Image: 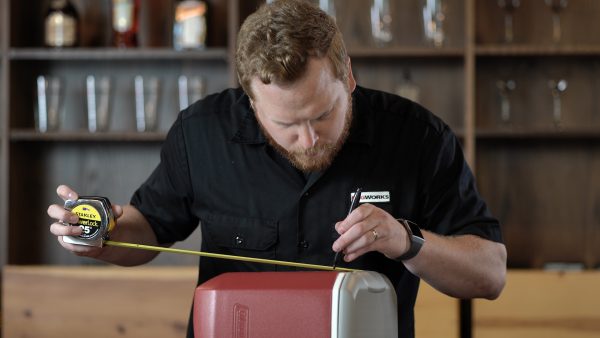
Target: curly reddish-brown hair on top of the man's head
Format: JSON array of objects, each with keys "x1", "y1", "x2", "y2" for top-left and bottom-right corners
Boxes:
[{"x1": 235, "y1": 0, "x2": 349, "y2": 98}]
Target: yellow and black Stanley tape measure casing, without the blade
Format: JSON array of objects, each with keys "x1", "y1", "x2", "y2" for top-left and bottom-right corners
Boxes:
[{"x1": 63, "y1": 196, "x2": 115, "y2": 247}]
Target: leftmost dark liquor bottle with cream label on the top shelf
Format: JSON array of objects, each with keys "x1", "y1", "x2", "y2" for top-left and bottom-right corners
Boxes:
[{"x1": 44, "y1": 0, "x2": 79, "y2": 48}]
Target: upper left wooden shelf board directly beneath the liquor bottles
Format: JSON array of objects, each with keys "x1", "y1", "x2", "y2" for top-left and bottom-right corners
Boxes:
[{"x1": 9, "y1": 48, "x2": 228, "y2": 62}]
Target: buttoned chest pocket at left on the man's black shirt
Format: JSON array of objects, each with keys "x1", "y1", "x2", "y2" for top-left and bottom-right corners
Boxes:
[{"x1": 202, "y1": 213, "x2": 278, "y2": 256}]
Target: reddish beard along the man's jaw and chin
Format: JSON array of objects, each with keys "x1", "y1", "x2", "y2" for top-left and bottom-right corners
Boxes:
[{"x1": 257, "y1": 96, "x2": 352, "y2": 173}]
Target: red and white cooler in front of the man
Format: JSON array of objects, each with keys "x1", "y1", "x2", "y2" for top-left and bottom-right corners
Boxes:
[{"x1": 194, "y1": 271, "x2": 398, "y2": 338}]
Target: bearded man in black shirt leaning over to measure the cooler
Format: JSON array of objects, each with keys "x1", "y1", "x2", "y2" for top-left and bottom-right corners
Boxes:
[{"x1": 48, "y1": 0, "x2": 506, "y2": 337}]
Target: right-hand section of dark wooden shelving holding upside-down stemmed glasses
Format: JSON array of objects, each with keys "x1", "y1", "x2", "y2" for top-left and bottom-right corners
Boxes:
[{"x1": 473, "y1": 0, "x2": 600, "y2": 269}]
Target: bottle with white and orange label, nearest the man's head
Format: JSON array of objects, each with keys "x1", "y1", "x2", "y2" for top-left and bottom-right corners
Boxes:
[{"x1": 173, "y1": 0, "x2": 206, "y2": 50}]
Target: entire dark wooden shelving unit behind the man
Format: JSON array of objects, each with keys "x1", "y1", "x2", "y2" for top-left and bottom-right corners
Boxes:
[{"x1": 0, "y1": 0, "x2": 600, "y2": 336}]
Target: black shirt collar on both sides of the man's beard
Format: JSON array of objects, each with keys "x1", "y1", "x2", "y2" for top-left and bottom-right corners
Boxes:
[{"x1": 231, "y1": 86, "x2": 375, "y2": 145}]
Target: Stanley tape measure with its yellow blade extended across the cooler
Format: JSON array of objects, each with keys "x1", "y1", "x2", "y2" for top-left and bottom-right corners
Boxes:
[{"x1": 63, "y1": 196, "x2": 359, "y2": 272}]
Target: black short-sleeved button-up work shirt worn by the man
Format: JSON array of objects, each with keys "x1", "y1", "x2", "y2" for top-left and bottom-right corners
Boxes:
[{"x1": 131, "y1": 87, "x2": 501, "y2": 337}]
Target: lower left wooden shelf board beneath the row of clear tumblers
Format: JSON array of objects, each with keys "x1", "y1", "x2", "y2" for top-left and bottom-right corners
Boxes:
[{"x1": 10, "y1": 129, "x2": 166, "y2": 142}]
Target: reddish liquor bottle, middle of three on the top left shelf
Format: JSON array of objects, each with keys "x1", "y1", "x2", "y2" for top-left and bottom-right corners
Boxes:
[{"x1": 112, "y1": 0, "x2": 140, "y2": 48}]
